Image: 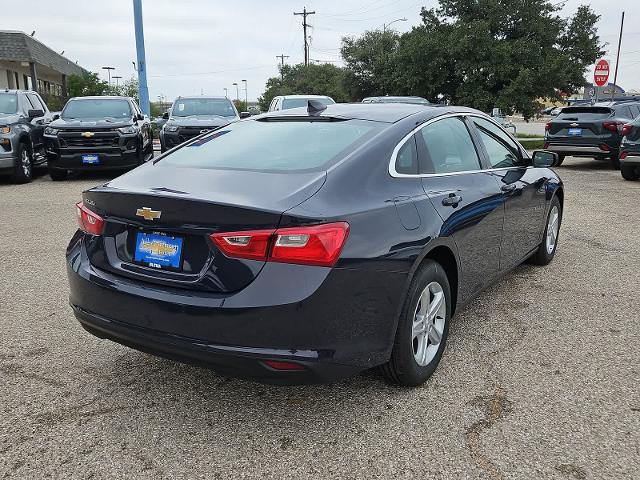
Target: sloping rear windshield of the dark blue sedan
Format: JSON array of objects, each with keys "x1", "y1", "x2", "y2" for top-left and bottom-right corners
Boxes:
[{"x1": 158, "y1": 120, "x2": 384, "y2": 172}]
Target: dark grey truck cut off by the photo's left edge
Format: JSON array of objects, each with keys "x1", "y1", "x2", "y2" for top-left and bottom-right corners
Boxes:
[{"x1": 0, "y1": 90, "x2": 51, "y2": 183}]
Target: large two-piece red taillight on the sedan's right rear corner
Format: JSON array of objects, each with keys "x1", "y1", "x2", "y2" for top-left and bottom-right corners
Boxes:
[{"x1": 211, "y1": 222, "x2": 349, "y2": 267}]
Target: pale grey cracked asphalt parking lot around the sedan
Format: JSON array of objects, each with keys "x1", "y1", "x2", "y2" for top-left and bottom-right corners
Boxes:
[{"x1": 0, "y1": 158, "x2": 640, "y2": 480}]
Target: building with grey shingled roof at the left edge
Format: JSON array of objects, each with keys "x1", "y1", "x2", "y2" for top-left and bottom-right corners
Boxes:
[{"x1": 0, "y1": 30, "x2": 86, "y2": 97}]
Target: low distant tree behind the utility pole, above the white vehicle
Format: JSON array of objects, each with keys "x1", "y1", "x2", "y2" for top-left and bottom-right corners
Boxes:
[{"x1": 258, "y1": 63, "x2": 350, "y2": 111}]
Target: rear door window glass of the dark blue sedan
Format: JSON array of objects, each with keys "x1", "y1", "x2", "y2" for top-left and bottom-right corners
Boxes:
[{"x1": 418, "y1": 117, "x2": 480, "y2": 173}]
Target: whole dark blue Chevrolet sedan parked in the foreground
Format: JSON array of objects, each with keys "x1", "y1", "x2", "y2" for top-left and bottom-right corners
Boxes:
[{"x1": 67, "y1": 101, "x2": 564, "y2": 385}]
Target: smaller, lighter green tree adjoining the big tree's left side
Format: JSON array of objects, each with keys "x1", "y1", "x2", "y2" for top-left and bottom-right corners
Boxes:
[{"x1": 341, "y1": 30, "x2": 400, "y2": 100}]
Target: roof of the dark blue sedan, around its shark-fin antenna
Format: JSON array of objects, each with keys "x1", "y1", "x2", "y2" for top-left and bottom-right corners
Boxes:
[{"x1": 256, "y1": 103, "x2": 484, "y2": 123}]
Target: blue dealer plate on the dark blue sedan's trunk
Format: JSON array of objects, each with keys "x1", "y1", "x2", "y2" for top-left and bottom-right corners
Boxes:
[{"x1": 133, "y1": 232, "x2": 183, "y2": 270}]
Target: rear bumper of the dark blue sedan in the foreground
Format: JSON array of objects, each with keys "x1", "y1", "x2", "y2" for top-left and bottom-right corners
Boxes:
[{"x1": 67, "y1": 235, "x2": 407, "y2": 383}]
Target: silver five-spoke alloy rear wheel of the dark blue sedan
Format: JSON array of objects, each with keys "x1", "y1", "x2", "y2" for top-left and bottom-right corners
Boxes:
[{"x1": 411, "y1": 282, "x2": 447, "y2": 367}]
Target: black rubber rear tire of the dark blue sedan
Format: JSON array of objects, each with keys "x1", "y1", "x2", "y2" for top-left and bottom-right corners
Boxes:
[{"x1": 381, "y1": 260, "x2": 452, "y2": 387}]
